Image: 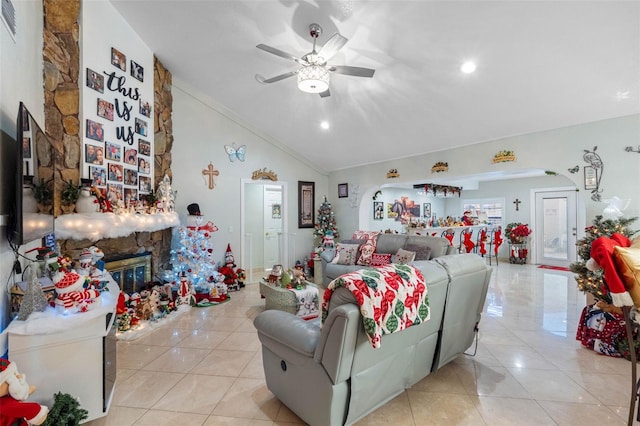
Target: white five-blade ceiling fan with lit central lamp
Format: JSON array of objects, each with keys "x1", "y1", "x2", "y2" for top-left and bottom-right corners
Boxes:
[{"x1": 256, "y1": 24, "x2": 375, "y2": 98}]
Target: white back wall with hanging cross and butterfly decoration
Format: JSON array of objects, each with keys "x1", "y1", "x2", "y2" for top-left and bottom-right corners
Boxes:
[{"x1": 171, "y1": 83, "x2": 327, "y2": 266}]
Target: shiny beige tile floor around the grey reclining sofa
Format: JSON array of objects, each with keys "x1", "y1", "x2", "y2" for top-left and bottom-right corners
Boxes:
[{"x1": 90, "y1": 263, "x2": 631, "y2": 426}]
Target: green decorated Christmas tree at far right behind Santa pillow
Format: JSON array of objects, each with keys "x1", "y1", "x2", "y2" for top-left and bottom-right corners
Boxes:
[{"x1": 571, "y1": 215, "x2": 637, "y2": 304}]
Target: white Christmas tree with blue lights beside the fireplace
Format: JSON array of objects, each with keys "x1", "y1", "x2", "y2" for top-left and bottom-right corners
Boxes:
[{"x1": 171, "y1": 222, "x2": 219, "y2": 292}]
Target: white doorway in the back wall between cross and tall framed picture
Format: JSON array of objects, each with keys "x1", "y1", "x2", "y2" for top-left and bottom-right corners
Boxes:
[{"x1": 240, "y1": 179, "x2": 288, "y2": 282}]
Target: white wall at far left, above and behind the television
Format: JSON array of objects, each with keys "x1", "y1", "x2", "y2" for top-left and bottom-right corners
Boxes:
[{"x1": 0, "y1": 0, "x2": 44, "y2": 355}]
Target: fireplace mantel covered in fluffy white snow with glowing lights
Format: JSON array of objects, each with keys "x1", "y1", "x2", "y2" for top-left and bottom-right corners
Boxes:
[{"x1": 55, "y1": 212, "x2": 180, "y2": 241}]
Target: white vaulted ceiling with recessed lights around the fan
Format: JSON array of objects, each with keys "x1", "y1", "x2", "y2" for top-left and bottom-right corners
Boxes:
[{"x1": 111, "y1": 0, "x2": 640, "y2": 171}]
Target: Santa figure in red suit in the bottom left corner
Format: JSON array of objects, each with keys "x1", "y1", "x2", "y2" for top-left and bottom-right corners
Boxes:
[{"x1": 0, "y1": 358, "x2": 49, "y2": 426}]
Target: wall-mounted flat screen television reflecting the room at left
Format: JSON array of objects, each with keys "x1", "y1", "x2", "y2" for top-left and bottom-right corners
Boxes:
[{"x1": 4, "y1": 102, "x2": 55, "y2": 248}]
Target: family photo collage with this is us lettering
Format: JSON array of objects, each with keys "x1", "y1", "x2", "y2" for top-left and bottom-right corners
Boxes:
[{"x1": 83, "y1": 47, "x2": 153, "y2": 206}]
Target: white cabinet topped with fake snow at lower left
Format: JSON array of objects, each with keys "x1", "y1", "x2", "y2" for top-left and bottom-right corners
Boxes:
[{"x1": 7, "y1": 282, "x2": 118, "y2": 421}]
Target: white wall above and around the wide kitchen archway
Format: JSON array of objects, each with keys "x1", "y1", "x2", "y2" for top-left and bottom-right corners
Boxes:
[{"x1": 329, "y1": 115, "x2": 640, "y2": 240}]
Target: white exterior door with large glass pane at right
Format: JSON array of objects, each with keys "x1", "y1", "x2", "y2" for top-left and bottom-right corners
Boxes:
[{"x1": 534, "y1": 190, "x2": 577, "y2": 268}]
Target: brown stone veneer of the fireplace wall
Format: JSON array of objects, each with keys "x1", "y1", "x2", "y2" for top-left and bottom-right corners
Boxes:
[{"x1": 42, "y1": 0, "x2": 173, "y2": 275}]
